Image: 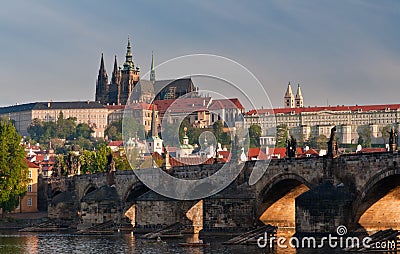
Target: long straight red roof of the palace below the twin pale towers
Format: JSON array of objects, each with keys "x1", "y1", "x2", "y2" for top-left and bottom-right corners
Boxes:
[{"x1": 246, "y1": 104, "x2": 400, "y2": 115}]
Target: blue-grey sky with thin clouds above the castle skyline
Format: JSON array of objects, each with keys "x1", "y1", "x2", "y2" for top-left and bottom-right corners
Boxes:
[{"x1": 0, "y1": 0, "x2": 400, "y2": 107}]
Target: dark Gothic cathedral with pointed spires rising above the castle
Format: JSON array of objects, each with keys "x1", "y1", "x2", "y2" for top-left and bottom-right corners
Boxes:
[{"x1": 95, "y1": 37, "x2": 197, "y2": 105}]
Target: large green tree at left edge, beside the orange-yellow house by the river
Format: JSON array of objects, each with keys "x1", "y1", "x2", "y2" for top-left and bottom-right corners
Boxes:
[{"x1": 0, "y1": 120, "x2": 29, "y2": 214}]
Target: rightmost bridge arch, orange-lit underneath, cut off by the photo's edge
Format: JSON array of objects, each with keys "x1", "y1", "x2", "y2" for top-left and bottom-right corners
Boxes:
[{"x1": 353, "y1": 167, "x2": 400, "y2": 231}]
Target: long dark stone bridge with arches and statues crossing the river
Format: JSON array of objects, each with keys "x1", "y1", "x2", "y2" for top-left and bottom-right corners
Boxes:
[{"x1": 48, "y1": 153, "x2": 400, "y2": 233}]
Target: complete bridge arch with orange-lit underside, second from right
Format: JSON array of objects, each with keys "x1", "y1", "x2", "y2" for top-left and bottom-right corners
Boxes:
[{"x1": 256, "y1": 173, "x2": 312, "y2": 227}]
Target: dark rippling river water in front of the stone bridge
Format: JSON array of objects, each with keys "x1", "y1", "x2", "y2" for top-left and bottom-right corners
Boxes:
[{"x1": 0, "y1": 231, "x2": 346, "y2": 254}]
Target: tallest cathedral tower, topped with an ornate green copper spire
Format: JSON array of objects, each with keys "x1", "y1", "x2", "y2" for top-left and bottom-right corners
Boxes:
[{"x1": 118, "y1": 36, "x2": 140, "y2": 104}]
